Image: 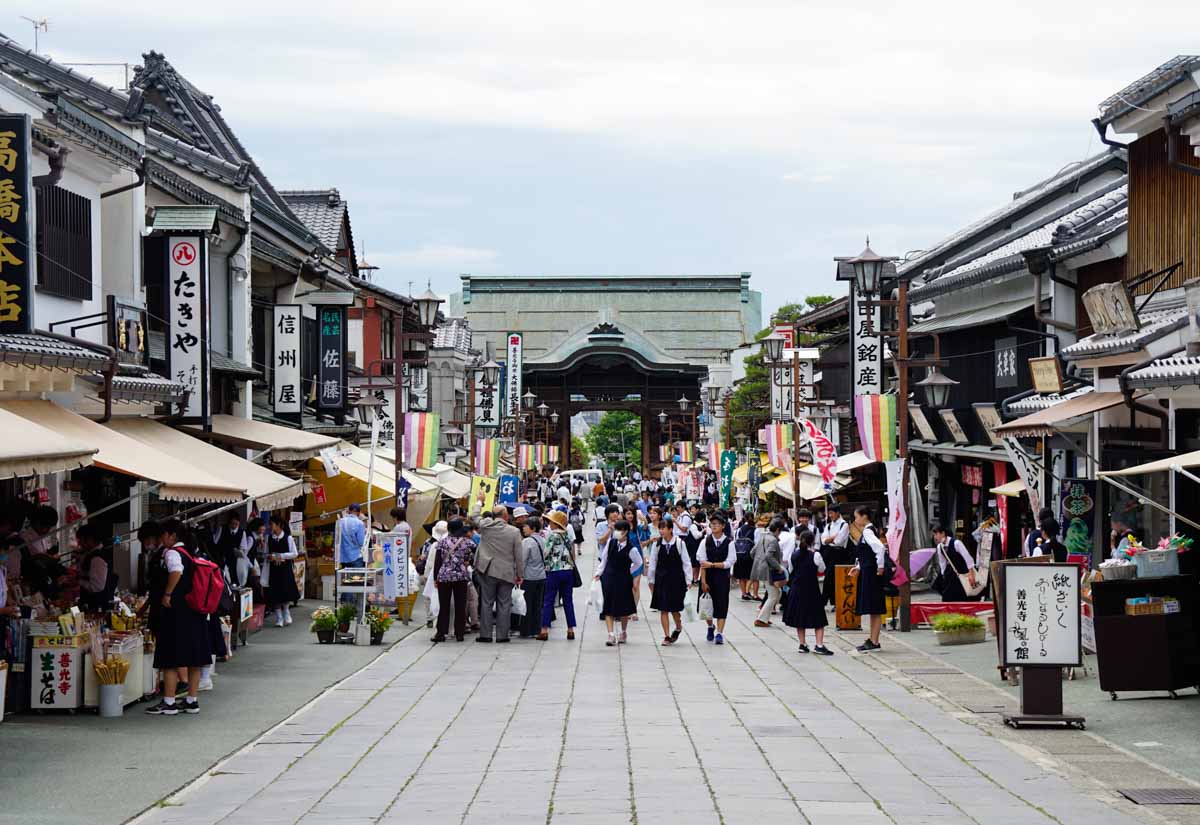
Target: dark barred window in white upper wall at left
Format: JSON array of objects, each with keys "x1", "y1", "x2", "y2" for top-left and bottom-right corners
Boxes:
[{"x1": 37, "y1": 186, "x2": 91, "y2": 301}]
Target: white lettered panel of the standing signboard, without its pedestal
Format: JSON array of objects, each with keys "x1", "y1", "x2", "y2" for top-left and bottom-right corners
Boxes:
[{"x1": 1002, "y1": 564, "x2": 1081, "y2": 668}]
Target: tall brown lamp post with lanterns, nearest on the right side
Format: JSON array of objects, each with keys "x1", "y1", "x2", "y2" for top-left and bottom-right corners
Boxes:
[{"x1": 847, "y1": 239, "x2": 958, "y2": 633}]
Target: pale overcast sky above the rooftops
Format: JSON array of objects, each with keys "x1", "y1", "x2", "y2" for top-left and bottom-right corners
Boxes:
[{"x1": 14, "y1": 0, "x2": 1200, "y2": 323}]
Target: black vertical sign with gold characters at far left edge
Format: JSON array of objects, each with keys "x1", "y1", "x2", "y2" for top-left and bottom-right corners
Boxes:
[{"x1": 0, "y1": 114, "x2": 34, "y2": 332}]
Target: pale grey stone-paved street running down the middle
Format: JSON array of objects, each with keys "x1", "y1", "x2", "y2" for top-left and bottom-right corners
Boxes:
[{"x1": 129, "y1": 534, "x2": 1144, "y2": 825}]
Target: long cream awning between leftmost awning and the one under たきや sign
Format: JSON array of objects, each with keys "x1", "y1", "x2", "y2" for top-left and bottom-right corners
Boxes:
[{"x1": 0, "y1": 401, "x2": 246, "y2": 502}]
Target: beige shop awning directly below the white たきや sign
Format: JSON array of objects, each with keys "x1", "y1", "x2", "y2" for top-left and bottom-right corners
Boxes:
[{"x1": 107, "y1": 418, "x2": 304, "y2": 510}]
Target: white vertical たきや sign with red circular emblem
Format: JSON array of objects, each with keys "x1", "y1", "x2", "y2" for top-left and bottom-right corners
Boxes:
[{"x1": 167, "y1": 235, "x2": 210, "y2": 427}]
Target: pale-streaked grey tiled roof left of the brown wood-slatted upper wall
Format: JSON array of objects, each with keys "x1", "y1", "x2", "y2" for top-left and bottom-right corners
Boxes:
[{"x1": 910, "y1": 179, "x2": 1128, "y2": 301}]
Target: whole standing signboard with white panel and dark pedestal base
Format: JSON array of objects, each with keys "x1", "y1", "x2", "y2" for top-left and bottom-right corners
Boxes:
[{"x1": 1001, "y1": 564, "x2": 1084, "y2": 727}]
